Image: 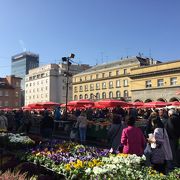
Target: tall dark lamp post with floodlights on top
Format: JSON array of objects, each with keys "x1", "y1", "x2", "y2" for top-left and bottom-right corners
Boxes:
[{"x1": 62, "y1": 54, "x2": 75, "y2": 120}]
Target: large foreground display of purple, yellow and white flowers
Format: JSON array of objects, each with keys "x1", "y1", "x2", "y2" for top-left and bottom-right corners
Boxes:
[{"x1": 25, "y1": 140, "x2": 179, "y2": 180}]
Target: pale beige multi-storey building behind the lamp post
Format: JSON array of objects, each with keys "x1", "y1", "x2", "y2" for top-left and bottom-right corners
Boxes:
[{"x1": 25, "y1": 63, "x2": 89, "y2": 105}]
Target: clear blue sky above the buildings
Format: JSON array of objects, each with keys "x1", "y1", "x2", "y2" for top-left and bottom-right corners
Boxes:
[{"x1": 0, "y1": 0, "x2": 180, "y2": 77}]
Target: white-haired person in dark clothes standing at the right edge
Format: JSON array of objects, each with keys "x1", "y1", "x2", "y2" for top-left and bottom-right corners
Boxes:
[{"x1": 166, "y1": 109, "x2": 180, "y2": 167}]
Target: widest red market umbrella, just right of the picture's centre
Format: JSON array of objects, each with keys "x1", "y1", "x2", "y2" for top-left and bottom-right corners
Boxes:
[{"x1": 95, "y1": 99, "x2": 128, "y2": 107}]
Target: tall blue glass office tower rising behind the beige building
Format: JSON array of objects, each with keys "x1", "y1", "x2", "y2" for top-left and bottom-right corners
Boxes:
[{"x1": 11, "y1": 52, "x2": 39, "y2": 105}]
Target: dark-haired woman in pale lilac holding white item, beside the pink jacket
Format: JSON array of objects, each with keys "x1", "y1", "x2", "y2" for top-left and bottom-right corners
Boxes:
[{"x1": 148, "y1": 117, "x2": 172, "y2": 174}]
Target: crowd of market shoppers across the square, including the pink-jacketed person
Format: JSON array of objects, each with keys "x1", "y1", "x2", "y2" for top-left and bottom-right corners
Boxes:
[{"x1": 0, "y1": 107, "x2": 180, "y2": 173}]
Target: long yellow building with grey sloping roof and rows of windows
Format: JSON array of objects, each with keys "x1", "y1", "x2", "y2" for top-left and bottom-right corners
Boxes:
[{"x1": 73, "y1": 57, "x2": 158, "y2": 101}]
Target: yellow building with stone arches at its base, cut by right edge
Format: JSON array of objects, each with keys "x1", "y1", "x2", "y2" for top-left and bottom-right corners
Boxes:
[{"x1": 129, "y1": 60, "x2": 180, "y2": 102}]
